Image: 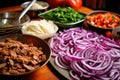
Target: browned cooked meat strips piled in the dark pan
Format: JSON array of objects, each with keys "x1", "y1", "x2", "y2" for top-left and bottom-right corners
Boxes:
[{"x1": 0, "y1": 38, "x2": 46, "y2": 74}]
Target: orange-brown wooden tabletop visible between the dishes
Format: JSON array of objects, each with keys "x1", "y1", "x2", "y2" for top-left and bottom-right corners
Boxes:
[{"x1": 0, "y1": 6, "x2": 92, "y2": 80}]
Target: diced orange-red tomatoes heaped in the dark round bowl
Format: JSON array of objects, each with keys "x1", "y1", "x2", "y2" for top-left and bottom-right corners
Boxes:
[{"x1": 87, "y1": 12, "x2": 120, "y2": 29}]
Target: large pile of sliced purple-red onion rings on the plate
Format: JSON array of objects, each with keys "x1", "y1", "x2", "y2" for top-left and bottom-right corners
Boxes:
[{"x1": 50, "y1": 28, "x2": 120, "y2": 80}]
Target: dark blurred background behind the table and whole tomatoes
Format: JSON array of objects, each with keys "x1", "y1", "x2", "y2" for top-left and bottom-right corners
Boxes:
[{"x1": 0, "y1": 0, "x2": 120, "y2": 13}]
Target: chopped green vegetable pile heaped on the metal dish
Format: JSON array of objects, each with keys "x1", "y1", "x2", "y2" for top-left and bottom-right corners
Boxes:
[{"x1": 41, "y1": 7, "x2": 85, "y2": 23}]
